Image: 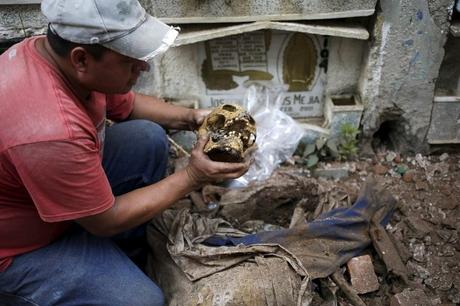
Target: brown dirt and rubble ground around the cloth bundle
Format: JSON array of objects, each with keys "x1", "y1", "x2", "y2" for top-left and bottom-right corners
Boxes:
[{"x1": 167, "y1": 146, "x2": 460, "y2": 306}]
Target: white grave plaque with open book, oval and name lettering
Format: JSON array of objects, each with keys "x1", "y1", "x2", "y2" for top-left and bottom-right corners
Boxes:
[{"x1": 199, "y1": 30, "x2": 328, "y2": 118}]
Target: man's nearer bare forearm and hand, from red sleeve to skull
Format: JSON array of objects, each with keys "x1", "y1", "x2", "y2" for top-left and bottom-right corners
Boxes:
[{"x1": 76, "y1": 138, "x2": 250, "y2": 236}]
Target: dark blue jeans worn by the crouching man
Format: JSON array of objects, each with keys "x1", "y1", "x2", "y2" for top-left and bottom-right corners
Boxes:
[{"x1": 0, "y1": 120, "x2": 168, "y2": 306}]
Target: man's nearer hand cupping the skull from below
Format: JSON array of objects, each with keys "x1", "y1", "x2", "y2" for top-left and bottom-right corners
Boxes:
[{"x1": 185, "y1": 137, "x2": 252, "y2": 188}]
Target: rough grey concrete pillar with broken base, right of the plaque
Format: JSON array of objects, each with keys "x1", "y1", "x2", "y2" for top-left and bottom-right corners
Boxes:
[{"x1": 360, "y1": 0, "x2": 454, "y2": 151}]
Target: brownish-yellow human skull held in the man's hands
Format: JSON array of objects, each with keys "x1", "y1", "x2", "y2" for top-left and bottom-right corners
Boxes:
[{"x1": 198, "y1": 104, "x2": 256, "y2": 162}]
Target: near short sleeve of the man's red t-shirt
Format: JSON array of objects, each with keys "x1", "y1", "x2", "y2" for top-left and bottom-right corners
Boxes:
[{"x1": 8, "y1": 140, "x2": 115, "y2": 222}]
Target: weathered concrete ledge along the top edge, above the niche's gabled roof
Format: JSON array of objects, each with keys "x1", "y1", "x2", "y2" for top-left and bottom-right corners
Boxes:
[{"x1": 140, "y1": 0, "x2": 377, "y2": 23}]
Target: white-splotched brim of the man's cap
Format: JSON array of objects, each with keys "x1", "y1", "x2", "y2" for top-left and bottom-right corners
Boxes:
[{"x1": 102, "y1": 14, "x2": 179, "y2": 61}]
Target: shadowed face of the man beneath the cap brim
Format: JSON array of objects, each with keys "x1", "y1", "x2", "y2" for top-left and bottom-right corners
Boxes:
[{"x1": 83, "y1": 50, "x2": 150, "y2": 94}]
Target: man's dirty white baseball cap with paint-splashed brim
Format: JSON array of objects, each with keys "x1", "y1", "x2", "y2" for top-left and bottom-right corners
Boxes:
[{"x1": 41, "y1": 0, "x2": 179, "y2": 61}]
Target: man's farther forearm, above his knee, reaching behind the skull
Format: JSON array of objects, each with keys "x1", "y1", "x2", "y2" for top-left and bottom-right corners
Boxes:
[{"x1": 129, "y1": 93, "x2": 209, "y2": 130}]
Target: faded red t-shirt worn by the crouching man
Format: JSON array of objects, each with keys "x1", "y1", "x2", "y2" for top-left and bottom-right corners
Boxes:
[{"x1": 0, "y1": 37, "x2": 134, "y2": 271}]
